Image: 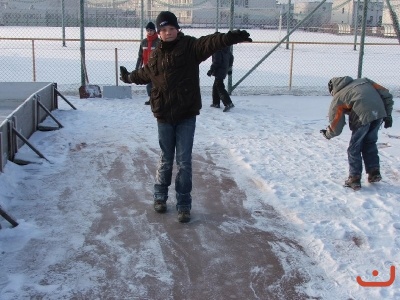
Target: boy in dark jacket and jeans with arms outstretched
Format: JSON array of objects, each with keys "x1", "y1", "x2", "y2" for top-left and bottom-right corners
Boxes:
[{"x1": 120, "y1": 11, "x2": 252, "y2": 222}]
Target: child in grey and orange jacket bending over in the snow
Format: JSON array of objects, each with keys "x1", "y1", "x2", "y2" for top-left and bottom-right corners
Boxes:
[{"x1": 321, "y1": 76, "x2": 393, "y2": 190}]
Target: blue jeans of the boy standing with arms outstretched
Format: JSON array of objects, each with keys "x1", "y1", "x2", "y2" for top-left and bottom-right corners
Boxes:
[{"x1": 154, "y1": 117, "x2": 196, "y2": 211}]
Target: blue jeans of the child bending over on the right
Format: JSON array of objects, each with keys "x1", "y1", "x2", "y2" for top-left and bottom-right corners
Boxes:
[{"x1": 347, "y1": 119, "x2": 382, "y2": 176}]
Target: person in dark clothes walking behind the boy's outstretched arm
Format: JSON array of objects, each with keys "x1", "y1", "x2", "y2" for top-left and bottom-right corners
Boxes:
[{"x1": 207, "y1": 47, "x2": 234, "y2": 112}]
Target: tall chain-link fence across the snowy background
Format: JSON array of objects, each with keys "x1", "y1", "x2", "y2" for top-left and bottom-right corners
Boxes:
[{"x1": 0, "y1": 0, "x2": 400, "y2": 97}]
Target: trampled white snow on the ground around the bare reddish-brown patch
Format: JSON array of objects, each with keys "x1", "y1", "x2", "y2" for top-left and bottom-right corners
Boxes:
[{"x1": 0, "y1": 95, "x2": 400, "y2": 299}]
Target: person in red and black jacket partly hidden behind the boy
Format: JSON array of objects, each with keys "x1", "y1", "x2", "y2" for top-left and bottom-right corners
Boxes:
[{"x1": 136, "y1": 22, "x2": 160, "y2": 105}]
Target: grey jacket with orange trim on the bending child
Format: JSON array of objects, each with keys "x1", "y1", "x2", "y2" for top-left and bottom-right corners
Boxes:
[{"x1": 326, "y1": 76, "x2": 393, "y2": 138}]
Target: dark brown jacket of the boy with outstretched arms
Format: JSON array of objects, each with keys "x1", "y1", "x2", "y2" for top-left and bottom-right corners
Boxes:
[{"x1": 130, "y1": 32, "x2": 233, "y2": 123}]
